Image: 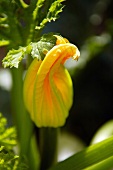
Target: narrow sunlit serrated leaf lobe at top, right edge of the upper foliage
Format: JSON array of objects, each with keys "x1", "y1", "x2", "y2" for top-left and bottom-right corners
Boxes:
[{"x1": 35, "y1": 0, "x2": 64, "y2": 30}]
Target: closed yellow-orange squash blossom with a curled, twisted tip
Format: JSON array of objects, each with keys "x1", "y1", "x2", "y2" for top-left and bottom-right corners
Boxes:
[{"x1": 24, "y1": 35, "x2": 80, "y2": 127}]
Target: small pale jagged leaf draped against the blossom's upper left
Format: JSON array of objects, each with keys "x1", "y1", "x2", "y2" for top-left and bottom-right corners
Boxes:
[{"x1": 3, "y1": 33, "x2": 56, "y2": 68}]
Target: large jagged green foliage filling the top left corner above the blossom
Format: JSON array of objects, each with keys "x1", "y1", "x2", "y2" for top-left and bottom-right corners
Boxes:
[{"x1": 0, "y1": 0, "x2": 64, "y2": 49}]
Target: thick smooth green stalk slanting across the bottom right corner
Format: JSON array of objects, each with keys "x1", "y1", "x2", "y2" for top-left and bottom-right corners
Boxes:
[{"x1": 50, "y1": 136, "x2": 113, "y2": 170}]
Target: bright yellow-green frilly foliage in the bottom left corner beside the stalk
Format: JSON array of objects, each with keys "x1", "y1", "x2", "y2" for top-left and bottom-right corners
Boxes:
[{"x1": 0, "y1": 113, "x2": 28, "y2": 170}]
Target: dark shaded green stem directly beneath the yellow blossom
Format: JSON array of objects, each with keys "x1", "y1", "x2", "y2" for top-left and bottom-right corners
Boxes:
[{"x1": 40, "y1": 128, "x2": 59, "y2": 170}]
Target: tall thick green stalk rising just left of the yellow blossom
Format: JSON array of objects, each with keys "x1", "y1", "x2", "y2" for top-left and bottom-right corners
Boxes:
[{"x1": 11, "y1": 65, "x2": 33, "y2": 155}]
